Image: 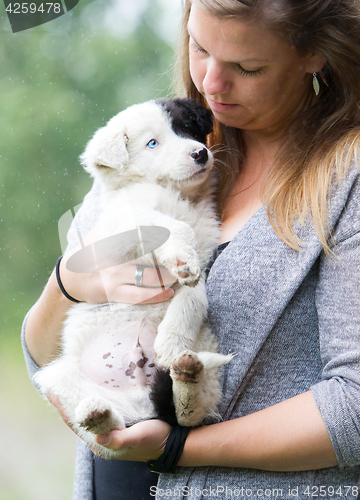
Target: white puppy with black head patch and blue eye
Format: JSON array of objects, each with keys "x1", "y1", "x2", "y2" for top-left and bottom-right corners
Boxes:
[{"x1": 35, "y1": 99, "x2": 231, "y2": 458}]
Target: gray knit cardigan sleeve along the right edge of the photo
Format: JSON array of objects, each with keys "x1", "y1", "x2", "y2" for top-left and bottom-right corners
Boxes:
[{"x1": 311, "y1": 176, "x2": 360, "y2": 467}]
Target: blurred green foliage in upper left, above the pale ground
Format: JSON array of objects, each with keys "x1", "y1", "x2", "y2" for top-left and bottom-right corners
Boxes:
[{"x1": 0, "y1": 0, "x2": 174, "y2": 344}]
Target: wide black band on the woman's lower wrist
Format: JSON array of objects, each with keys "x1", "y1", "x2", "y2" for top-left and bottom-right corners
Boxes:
[{"x1": 147, "y1": 425, "x2": 190, "y2": 473}]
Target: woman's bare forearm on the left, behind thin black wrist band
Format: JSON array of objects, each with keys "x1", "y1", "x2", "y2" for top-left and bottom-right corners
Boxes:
[{"x1": 25, "y1": 272, "x2": 73, "y2": 367}]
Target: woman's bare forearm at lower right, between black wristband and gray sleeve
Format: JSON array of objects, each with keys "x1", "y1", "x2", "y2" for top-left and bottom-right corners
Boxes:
[{"x1": 179, "y1": 391, "x2": 338, "y2": 471}]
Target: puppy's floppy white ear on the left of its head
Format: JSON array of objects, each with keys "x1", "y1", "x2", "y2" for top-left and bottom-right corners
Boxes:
[{"x1": 80, "y1": 126, "x2": 129, "y2": 176}]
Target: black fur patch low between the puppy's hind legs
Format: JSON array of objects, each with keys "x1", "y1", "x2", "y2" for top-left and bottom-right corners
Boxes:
[{"x1": 149, "y1": 369, "x2": 177, "y2": 426}]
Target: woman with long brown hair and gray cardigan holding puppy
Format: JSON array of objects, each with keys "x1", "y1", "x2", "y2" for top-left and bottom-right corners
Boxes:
[{"x1": 21, "y1": 0, "x2": 360, "y2": 499}]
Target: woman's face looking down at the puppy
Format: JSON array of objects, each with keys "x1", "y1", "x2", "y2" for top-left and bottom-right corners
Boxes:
[{"x1": 188, "y1": 5, "x2": 324, "y2": 135}]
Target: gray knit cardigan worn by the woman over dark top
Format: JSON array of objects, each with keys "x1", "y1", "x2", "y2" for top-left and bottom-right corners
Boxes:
[{"x1": 23, "y1": 165, "x2": 360, "y2": 500}]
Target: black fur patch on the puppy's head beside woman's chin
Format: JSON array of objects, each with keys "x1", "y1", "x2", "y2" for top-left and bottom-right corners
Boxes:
[{"x1": 155, "y1": 99, "x2": 213, "y2": 144}]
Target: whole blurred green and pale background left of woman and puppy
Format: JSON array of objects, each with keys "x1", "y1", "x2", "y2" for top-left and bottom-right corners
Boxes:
[{"x1": 0, "y1": 0, "x2": 181, "y2": 500}]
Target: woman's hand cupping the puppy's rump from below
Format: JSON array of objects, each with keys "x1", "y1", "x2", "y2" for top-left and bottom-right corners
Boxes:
[{"x1": 48, "y1": 394, "x2": 171, "y2": 462}]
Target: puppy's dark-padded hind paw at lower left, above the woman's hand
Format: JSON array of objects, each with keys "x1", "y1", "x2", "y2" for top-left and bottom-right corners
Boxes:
[{"x1": 75, "y1": 398, "x2": 125, "y2": 434}]
